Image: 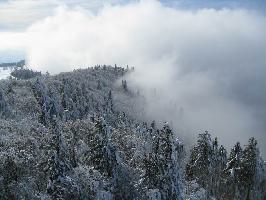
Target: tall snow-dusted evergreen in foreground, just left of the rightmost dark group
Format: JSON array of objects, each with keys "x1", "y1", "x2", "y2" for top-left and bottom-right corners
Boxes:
[{"x1": 144, "y1": 124, "x2": 182, "y2": 199}]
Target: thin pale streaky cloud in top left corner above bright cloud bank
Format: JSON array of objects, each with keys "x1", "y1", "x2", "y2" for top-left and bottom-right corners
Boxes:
[{"x1": 0, "y1": 0, "x2": 128, "y2": 30}]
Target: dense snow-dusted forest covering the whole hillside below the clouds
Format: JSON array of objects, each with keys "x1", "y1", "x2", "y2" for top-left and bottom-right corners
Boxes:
[{"x1": 0, "y1": 65, "x2": 266, "y2": 200}]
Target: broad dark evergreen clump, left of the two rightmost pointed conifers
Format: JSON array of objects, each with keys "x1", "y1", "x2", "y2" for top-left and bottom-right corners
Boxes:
[{"x1": 186, "y1": 131, "x2": 227, "y2": 199}]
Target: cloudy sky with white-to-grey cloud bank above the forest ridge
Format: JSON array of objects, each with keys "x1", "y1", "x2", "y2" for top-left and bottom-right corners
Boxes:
[{"x1": 0, "y1": 0, "x2": 266, "y2": 157}]
